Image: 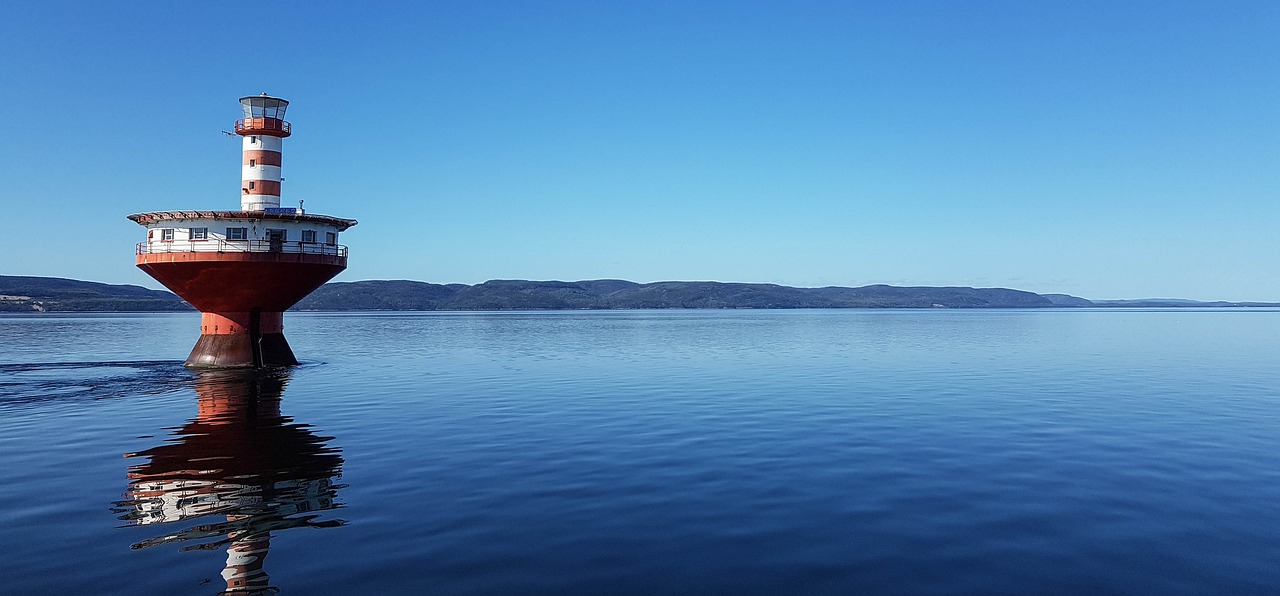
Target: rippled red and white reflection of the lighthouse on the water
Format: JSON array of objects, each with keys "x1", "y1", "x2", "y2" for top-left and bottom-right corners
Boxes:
[{"x1": 115, "y1": 368, "x2": 344, "y2": 595}]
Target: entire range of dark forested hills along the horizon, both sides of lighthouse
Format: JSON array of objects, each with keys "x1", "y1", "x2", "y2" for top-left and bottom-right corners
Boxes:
[{"x1": 0, "y1": 275, "x2": 1280, "y2": 312}]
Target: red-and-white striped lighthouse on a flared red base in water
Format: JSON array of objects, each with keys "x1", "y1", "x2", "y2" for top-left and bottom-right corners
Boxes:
[{"x1": 129, "y1": 93, "x2": 356, "y2": 367}]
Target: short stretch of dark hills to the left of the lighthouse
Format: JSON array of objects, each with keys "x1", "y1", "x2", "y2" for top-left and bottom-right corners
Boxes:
[{"x1": 0, "y1": 275, "x2": 191, "y2": 312}]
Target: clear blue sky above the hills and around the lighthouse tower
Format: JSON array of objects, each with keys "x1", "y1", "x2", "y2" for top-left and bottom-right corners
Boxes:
[{"x1": 0, "y1": 0, "x2": 1280, "y2": 301}]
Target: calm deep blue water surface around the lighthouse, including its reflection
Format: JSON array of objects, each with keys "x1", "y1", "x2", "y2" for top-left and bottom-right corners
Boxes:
[{"x1": 0, "y1": 310, "x2": 1280, "y2": 595}]
